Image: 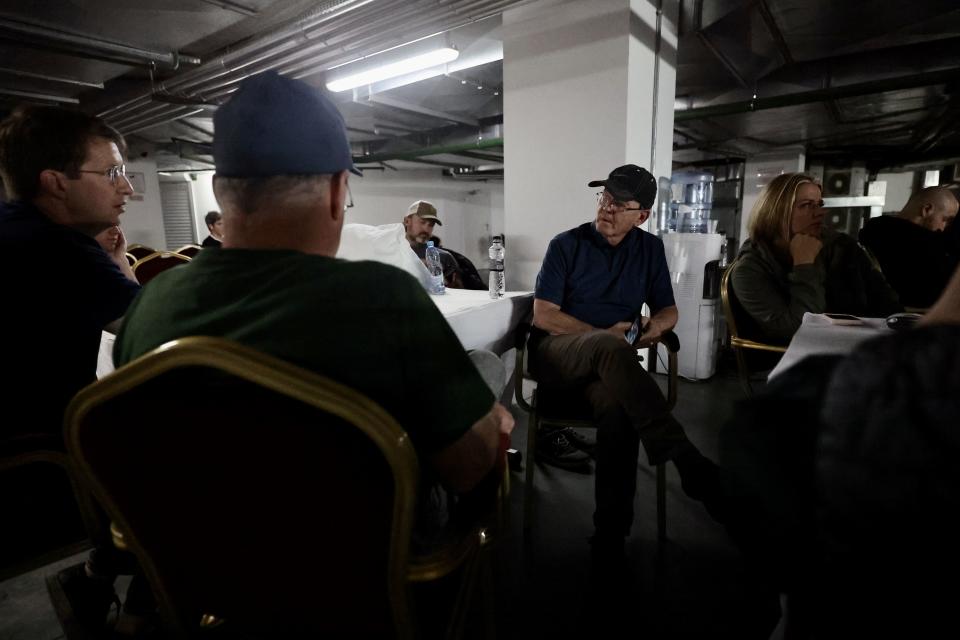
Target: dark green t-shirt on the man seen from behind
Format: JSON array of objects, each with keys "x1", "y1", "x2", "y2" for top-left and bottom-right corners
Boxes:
[{"x1": 113, "y1": 249, "x2": 494, "y2": 453}]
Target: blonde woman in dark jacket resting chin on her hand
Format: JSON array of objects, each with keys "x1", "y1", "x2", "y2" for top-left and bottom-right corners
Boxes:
[{"x1": 731, "y1": 173, "x2": 902, "y2": 344}]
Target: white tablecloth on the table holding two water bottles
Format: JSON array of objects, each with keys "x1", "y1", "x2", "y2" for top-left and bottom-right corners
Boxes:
[{"x1": 97, "y1": 289, "x2": 533, "y2": 378}]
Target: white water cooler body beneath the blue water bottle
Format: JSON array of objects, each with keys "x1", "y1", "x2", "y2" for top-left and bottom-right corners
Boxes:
[{"x1": 659, "y1": 233, "x2": 724, "y2": 380}]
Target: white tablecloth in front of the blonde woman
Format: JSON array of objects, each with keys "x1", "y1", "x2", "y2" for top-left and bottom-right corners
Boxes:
[{"x1": 767, "y1": 313, "x2": 891, "y2": 380}]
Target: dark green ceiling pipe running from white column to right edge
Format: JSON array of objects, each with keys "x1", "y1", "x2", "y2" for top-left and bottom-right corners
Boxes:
[{"x1": 673, "y1": 68, "x2": 960, "y2": 122}]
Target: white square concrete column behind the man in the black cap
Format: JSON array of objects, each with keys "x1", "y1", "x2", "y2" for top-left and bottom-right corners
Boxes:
[{"x1": 503, "y1": 0, "x2": 679, "y2": 289}]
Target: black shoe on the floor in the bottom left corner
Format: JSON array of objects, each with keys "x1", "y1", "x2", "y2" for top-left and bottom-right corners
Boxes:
[{"x1": 47, "y1": 562, "x2": 120, "y2": 639}]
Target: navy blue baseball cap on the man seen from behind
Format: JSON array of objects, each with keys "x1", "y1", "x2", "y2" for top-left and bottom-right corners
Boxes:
[{"x1": 213, "y1": 71, "x2": 361, "y2": 178}]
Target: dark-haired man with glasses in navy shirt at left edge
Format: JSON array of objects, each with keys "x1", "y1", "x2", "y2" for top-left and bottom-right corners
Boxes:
[{"x1": 0, "y1": 107, "x2": 140, "y2": 437}]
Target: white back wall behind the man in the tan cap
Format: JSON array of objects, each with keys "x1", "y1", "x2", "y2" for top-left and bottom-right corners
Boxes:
[{"x1": 184, "y1": 169, "x2": 510, "y2": 269}]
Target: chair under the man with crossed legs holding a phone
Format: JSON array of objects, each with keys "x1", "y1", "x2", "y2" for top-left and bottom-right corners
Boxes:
[{"x1": 514, "y1": 324, "x2": 680, "y2": 547}]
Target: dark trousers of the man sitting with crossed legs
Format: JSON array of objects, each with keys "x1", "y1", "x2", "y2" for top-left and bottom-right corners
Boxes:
[{"x1": 530, "y1": 331, "x2": 693, "y2": 535}]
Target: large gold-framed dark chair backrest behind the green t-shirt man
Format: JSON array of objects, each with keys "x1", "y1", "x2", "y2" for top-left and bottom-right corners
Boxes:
[{"x1": 66, "y1": 338, "x2": 417, "y2": 637}]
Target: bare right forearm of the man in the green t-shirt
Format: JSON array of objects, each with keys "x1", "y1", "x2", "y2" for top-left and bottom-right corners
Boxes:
[{"x1": 431, "y1": 402, "x2": 513, "y2": 493}]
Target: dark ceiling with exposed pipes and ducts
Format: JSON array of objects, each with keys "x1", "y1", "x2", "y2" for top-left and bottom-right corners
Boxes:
[{"x1": 0, "y1": 0, "x2": 960, "y2": 178}]
